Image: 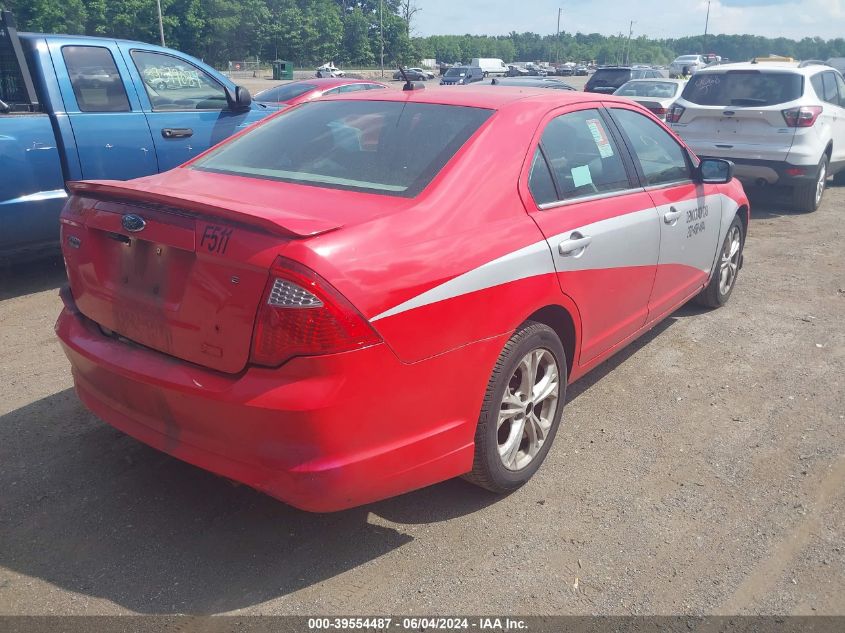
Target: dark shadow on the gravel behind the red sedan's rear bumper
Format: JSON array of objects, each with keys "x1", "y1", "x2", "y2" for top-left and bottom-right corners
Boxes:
[{"x1": 0, "y1": 389, "x2": 498, "y2": 614}]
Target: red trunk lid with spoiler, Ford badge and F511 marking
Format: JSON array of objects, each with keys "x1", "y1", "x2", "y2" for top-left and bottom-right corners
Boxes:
[{"x1": 62, "y1": 170, "x2": 352, "y2": 373}]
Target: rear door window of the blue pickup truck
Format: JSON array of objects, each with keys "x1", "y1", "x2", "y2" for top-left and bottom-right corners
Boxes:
[{"x1": 62, "y1": 46, "x2": 129, "y2": 112}]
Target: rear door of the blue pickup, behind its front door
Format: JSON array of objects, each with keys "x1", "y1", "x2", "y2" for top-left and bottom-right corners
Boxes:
[{"x1": 48, "y1": 39, "x2": 158, "y2": 180}]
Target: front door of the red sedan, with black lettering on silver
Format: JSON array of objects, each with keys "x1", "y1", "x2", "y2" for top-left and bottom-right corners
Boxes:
[{"x1": 608, "y1": 104, "x2": 722, "y2": 320}]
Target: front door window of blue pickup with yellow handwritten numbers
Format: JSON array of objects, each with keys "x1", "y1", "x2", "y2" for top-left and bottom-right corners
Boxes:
[{"x1": 131, "y1": 51, "x2": 227, "y2": 110}]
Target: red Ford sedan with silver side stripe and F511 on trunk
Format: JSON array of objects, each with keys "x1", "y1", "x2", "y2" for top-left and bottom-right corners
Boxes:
[{"x1": 56, "y1": 87, "x2": 749, "y2": 511}]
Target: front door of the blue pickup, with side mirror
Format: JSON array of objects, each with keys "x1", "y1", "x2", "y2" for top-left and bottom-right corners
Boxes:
[{"x1": 121, "y1": 44, "x2": 267, "y2": 171}]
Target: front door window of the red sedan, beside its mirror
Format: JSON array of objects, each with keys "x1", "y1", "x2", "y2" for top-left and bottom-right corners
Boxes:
[{"x1": 611, "y1": 108, "x2": 691, "y2": 185}]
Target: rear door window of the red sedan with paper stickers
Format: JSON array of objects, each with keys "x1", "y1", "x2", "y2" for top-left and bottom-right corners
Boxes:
[{"x1": 540, "y1": 110, "x2": 629, "y2": 198}]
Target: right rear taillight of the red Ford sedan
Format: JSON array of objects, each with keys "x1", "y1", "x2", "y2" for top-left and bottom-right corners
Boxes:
[{"x1": 250, "y1": 257, "x2": 381, "y2": 367}]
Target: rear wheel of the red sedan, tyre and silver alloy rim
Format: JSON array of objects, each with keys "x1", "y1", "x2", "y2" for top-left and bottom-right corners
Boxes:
[{"x1": 465, "y1": 321, "x2": 567, "y2": 494}]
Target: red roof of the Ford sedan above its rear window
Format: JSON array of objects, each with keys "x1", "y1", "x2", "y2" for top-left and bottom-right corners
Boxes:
[{"x1": 316, "y1": 84, "x2": 630, "y2": 110}]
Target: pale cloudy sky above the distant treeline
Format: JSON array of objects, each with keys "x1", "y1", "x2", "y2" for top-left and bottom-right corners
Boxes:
[{"x1": 412, "y1": 0, "x2": 845, "y2": 40}]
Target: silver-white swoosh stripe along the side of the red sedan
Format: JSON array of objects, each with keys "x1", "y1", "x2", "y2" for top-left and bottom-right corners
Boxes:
[{"x1": 370, "y1": 194, "x2": 737, "y2": 321}]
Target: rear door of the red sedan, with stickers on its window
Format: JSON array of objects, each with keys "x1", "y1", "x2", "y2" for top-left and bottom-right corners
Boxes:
[{"x1": 523, "y1": 104, "x2": 660, "y2": 364}]
